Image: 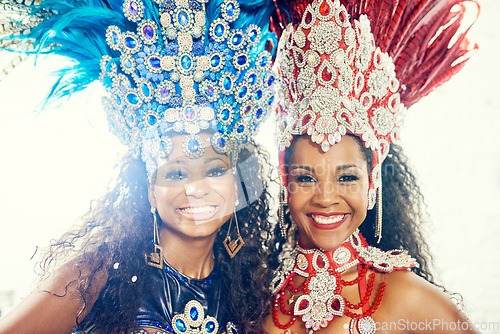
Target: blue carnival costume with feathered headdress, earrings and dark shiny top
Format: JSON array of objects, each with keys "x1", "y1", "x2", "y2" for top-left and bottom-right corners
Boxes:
[{"x1": 0, "y1": 0, "x2": 275, "y2": 333}]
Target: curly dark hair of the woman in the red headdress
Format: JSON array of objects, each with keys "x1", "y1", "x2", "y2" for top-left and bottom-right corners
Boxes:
[{"x1": 271, "y1": 134, "x2": 439, "y2": 286}]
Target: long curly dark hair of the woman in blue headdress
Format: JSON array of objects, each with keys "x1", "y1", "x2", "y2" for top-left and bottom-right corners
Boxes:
[{"x1": 39, "y1": 146, "x2": 272, "y2": 333}]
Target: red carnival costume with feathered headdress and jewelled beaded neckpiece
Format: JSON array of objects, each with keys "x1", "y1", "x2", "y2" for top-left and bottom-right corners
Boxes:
[{"x1": 272, "y1": 0, "x2": 477, "y2": 334}]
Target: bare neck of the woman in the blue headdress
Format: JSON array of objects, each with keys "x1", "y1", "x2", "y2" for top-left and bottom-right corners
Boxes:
[{"x1": 160, "y1": 228, "x2": 217, "y2": 279}]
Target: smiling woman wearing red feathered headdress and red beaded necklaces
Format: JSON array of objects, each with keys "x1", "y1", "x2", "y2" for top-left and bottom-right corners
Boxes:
[{"x1": 265, "y1": 0, "x2": 477, "y2": 334}]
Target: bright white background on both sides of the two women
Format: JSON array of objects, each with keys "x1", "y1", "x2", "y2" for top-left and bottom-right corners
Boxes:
[{"x1": 0, "y1": 0, "x2": 500, "y2": 333}]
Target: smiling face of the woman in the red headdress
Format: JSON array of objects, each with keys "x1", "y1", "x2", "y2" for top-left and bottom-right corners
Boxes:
[{"x1": 288, "y1": 136, "x2": 369, "y2": 250}]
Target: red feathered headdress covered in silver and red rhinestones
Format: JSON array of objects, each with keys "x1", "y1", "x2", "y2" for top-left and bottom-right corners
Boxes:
[{"x1": 276, "y1": 0, "x2": 476, "y2": 208}]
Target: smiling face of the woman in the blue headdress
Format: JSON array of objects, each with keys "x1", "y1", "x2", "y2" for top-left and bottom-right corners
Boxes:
[{"x1": 149, "y1": 134, "x2": 236, "y2": 238}]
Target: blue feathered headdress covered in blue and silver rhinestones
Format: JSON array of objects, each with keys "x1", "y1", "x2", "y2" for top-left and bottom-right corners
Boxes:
[{"x1": 0, "y1": 0, "x2": 275, "y2": 177}]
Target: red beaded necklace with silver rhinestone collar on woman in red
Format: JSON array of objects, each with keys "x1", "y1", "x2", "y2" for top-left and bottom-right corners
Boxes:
[{"x1": 272, "y1": 230, "x2": 415, "y2": 334}]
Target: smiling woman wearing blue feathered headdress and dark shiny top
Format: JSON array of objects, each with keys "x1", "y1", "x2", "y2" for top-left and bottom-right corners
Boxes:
[{"x1": 0, "y1": 0, "x2": 274, "y2": 334}]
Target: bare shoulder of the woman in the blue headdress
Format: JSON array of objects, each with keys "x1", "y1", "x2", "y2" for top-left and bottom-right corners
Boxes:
[{"x1": 0, "y1": 258, "x2": 107, "y2": 334}]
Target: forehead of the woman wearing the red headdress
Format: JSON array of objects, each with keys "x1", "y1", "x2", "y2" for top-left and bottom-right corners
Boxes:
[{"x1": 290, "y1": 136, "x2": 366, "y2": 168}]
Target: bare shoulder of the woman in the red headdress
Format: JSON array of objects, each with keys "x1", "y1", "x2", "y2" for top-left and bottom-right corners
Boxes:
[{"x1": 380, "y1": 271, "x2": 475, "y2": 333}]
